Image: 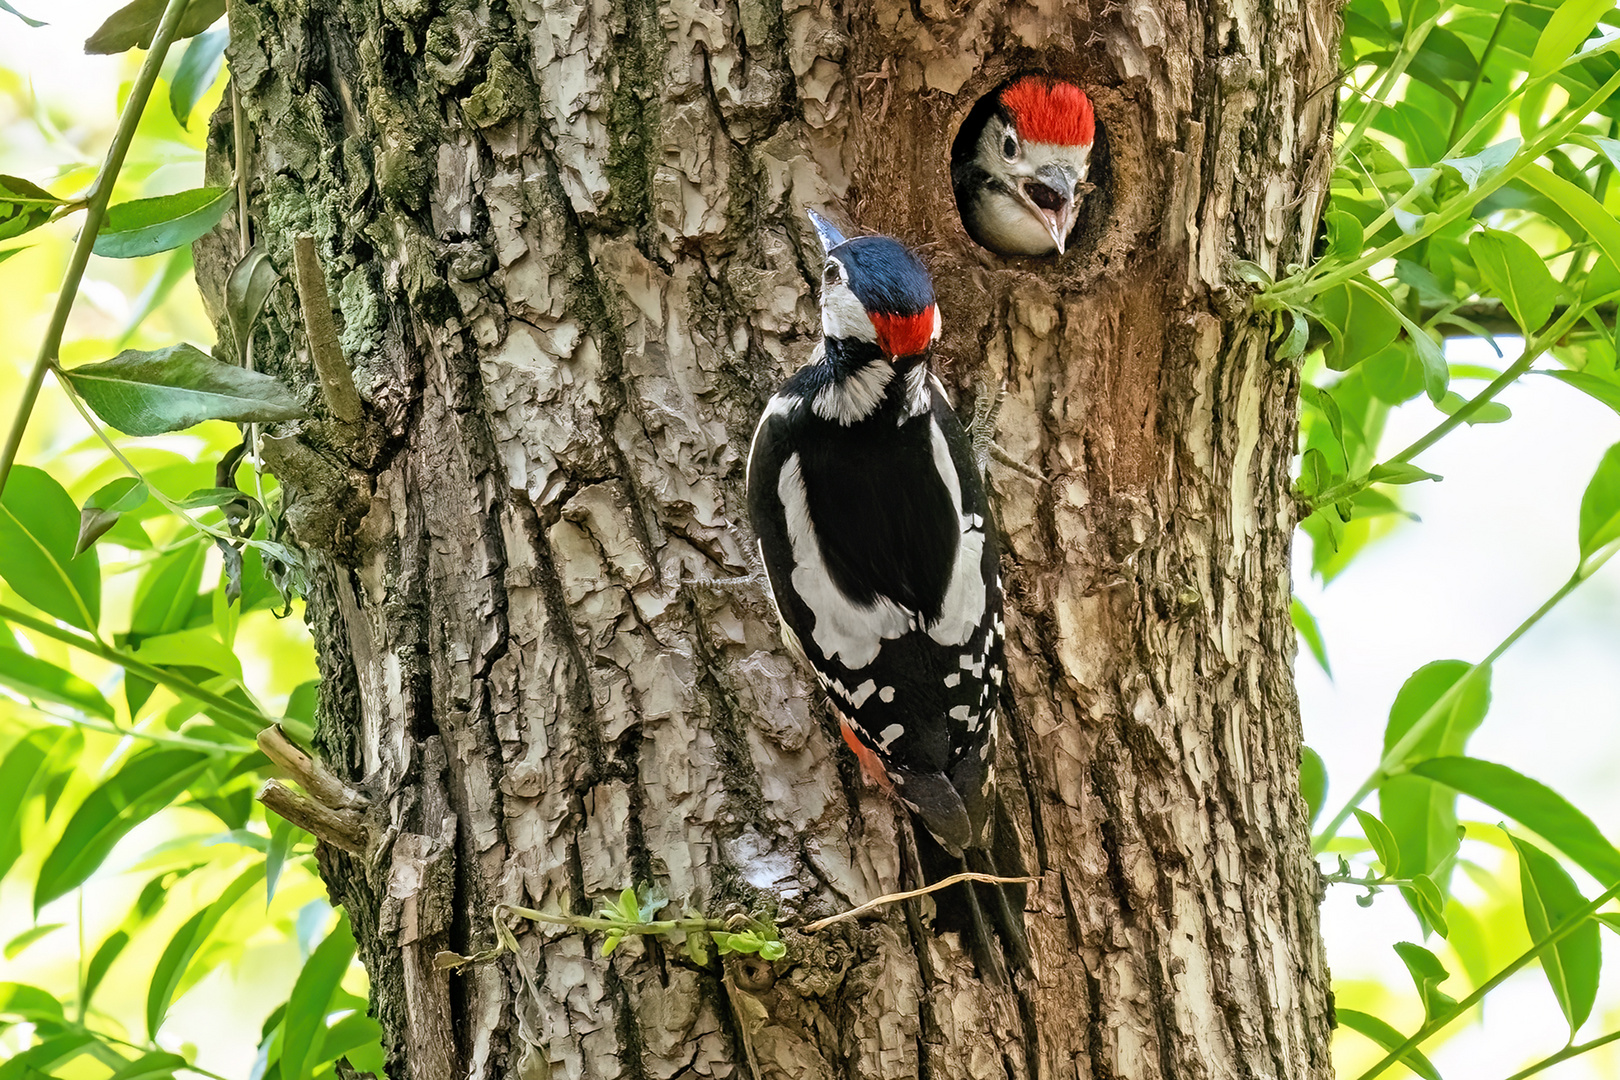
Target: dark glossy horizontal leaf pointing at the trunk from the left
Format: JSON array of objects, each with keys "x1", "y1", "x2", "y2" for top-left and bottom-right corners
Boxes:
[{"x1": 63, "y1": 345, "x2": 305, "y2": 436}]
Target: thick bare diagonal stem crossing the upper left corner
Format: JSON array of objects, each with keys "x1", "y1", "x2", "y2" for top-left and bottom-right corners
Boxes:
[{"x1": 0, "y1": 0, "x2": 191, "y2": 494}]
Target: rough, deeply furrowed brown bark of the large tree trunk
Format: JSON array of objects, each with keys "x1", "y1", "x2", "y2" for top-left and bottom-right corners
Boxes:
[{"x1": 199, "y1": 0, "x2": 1338, "y2": 1080}]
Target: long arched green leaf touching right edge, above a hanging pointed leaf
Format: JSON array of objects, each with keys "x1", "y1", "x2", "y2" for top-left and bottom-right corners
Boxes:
[{"x1": 1411, "y1": 756, "x2": 1620, "y2": 884}]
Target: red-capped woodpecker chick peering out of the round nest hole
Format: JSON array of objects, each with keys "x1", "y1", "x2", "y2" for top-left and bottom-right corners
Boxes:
[{"x1": 951, "y1": 74, "x2": 1097, "y2": 254}]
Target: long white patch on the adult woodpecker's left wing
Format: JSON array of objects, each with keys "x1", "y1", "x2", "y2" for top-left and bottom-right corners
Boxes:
[{"x1": 776, "y1": 453, "x2": 913, "y2": 667}]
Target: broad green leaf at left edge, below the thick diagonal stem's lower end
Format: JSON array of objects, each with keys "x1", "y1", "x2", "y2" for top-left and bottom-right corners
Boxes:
[{"x1": 0, "y1": 465, "x2": 100, "y2": 630}]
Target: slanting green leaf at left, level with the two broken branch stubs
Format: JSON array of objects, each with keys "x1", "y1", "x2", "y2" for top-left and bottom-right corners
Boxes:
[{"x1": 34, "y1": 746, "x2": 212, "y2": 912}]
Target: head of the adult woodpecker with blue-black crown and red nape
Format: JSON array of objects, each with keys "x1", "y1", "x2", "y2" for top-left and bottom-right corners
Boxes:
[{"x1": 810, "y1": 210, "x2": 940, "y2": 364}]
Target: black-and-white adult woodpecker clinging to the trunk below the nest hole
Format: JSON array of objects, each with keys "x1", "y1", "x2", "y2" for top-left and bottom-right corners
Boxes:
[{"x1": 748, "y1": 212, "x2": 1004, "y2": 858}]
